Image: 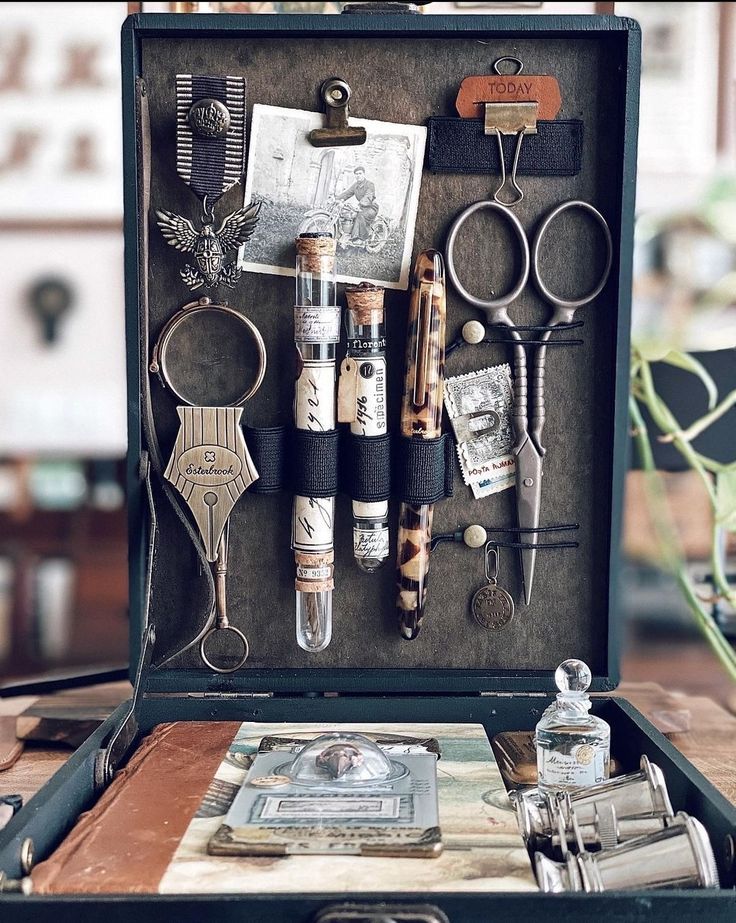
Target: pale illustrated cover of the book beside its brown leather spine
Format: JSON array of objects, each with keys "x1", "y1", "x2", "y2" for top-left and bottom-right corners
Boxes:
[{"x1": 159, "y1": 722, "x2": 537, "y2": 894}]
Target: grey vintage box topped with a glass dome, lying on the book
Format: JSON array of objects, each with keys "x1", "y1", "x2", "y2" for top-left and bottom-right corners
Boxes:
[{"x1": 213, "y1": 725, "x2": 442, "y2": 858}]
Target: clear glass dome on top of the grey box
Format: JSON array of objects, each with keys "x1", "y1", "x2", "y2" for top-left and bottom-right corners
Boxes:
[{"x1": 275, "y1": 732, "x2": 408, "y2": 788}]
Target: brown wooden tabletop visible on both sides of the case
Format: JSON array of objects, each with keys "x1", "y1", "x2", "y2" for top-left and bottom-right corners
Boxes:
[{"x1": 0, "y1": 683, "x2": 736, "y2": 804}]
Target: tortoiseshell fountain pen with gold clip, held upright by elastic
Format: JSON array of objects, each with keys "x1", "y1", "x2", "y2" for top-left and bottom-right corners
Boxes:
[{"x1": 396, "y1": 250, "x2": 445, "y2": 640}]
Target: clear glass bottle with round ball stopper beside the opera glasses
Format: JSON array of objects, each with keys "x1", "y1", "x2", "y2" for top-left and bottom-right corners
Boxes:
[{"x1": 535, "y1": 660, "x2": 611, "y2": 792}]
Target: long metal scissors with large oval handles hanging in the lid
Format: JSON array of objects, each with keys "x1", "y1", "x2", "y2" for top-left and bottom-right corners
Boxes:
[{"x1": 447, "y1": 199, "x2": 613, "y2": 605}]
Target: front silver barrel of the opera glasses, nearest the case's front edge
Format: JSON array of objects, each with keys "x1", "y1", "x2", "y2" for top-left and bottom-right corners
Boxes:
[{"x1": 534, "y1": 811, "x2": 719, "y2": 893}]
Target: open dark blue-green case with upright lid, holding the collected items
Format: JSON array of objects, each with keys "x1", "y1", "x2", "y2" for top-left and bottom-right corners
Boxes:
[{"x1": 0, "y1": 13, "x2": 736, "y2": 923}]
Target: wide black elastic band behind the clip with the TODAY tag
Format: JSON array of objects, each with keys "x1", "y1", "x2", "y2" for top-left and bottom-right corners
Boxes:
[{"x1": 427, "y1": 116, "x2": 583, "y2": 176}]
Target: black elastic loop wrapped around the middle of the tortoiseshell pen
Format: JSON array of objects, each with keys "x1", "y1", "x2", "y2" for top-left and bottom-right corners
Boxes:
[{"x1": 395, "y1": 433, "x2": 454, "y2": 506}]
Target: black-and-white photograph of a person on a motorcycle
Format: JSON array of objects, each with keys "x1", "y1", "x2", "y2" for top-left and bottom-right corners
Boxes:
[{"x1": 239, "y1": 105, "x2": 426, "y2": 289}]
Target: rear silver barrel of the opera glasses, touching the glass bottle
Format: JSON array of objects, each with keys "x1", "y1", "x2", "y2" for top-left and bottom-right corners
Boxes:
[{"x1": 514, "y1": 756, "x2": 674, "y2": 854}]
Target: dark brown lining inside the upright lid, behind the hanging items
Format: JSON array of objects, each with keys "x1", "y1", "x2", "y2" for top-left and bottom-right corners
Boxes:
[{"x1": 137, "y1": 17, "x2": 631, "y2": 692}]
